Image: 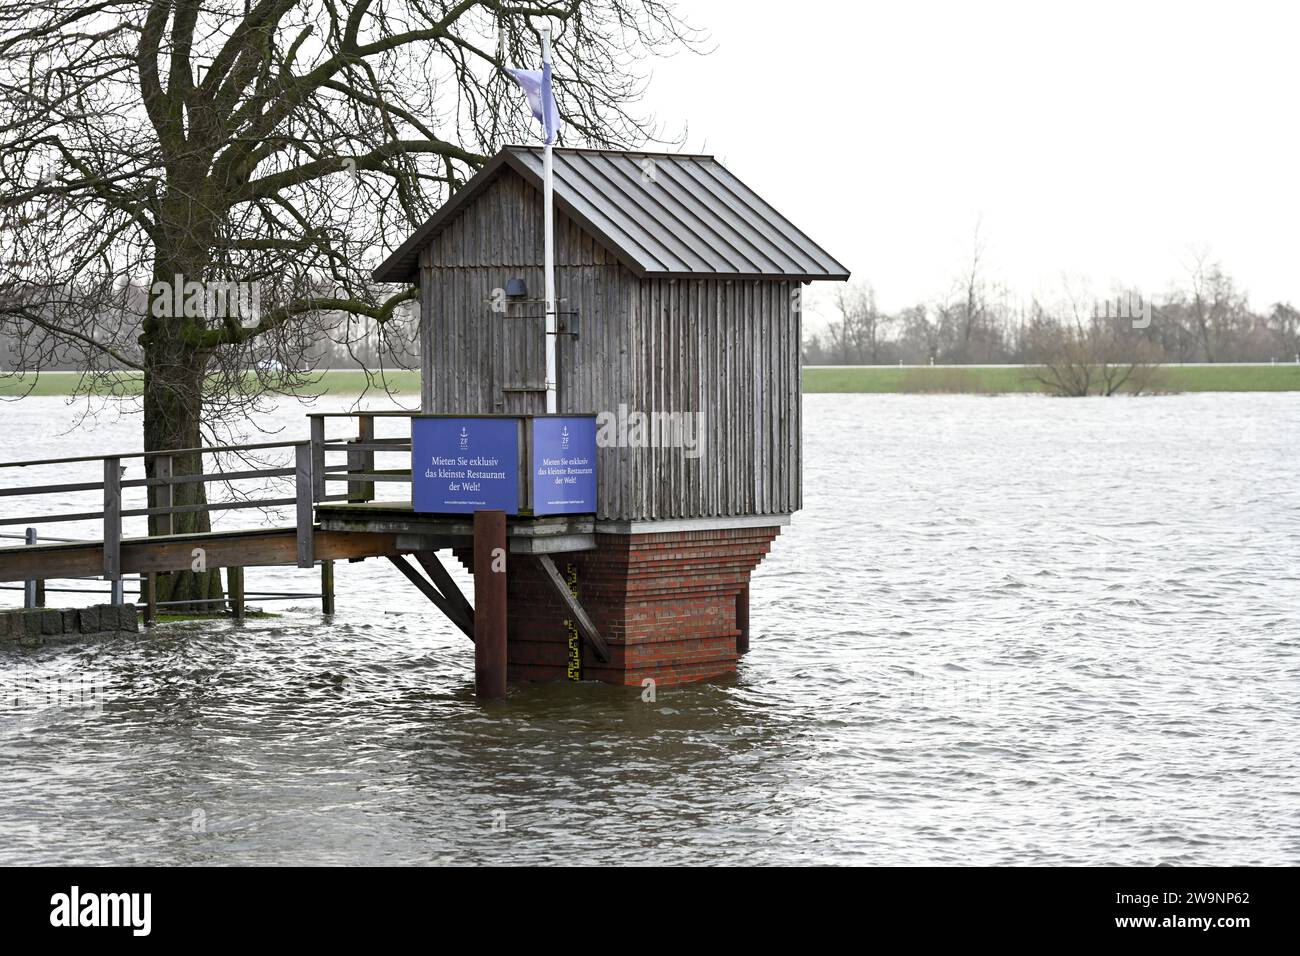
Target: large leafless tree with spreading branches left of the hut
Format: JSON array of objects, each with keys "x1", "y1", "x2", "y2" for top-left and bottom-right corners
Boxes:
[{"x1": 0, "y1": 0, "x2": 698, "y2": 598}]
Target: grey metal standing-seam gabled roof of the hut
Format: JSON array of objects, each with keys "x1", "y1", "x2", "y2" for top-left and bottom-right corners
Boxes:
[{"x1": 374, "y1": 146, "x2": 849, "y2": 282}]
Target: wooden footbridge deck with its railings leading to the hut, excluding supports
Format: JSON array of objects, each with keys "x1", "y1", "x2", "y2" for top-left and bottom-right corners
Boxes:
[{"x1": 0, "y1": 414, "x2": 595, "y2": 581}]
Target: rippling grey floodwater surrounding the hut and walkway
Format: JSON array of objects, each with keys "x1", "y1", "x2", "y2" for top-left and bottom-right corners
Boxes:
[{"x1": 0, "y1": 394, "x2": 1300, "y2": 865}]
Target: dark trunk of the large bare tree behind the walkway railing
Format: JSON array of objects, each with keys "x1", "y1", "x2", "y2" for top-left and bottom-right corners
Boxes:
[{"x1": 143, "y1": 265, "x2": 225, "y2": 614}]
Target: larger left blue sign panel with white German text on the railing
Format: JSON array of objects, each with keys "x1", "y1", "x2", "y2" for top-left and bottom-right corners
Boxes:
[{"x1": 411, "y1": 418, "x2": 519, "y2": 515}]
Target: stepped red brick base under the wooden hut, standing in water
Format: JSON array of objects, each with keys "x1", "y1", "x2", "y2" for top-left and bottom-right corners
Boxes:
[{"x1": 455, "y1": 527, "x2": 780, "y2": 685}]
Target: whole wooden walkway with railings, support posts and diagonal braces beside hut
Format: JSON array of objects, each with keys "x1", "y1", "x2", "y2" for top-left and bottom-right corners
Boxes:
[{"x1": 0, "y1": 412, "x2": 607, "y2": 659}]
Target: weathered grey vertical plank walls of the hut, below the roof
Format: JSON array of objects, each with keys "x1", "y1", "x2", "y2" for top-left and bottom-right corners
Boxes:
[{"x1": 420, "y1": 172, "x2": 801, "y2": 519}]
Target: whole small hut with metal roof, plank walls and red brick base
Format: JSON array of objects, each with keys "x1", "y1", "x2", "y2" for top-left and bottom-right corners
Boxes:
[{"x1": 374, "y1": 147, "x2": 848, "y2": 684}]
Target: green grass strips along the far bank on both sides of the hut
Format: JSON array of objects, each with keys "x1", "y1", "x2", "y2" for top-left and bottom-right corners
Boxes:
[{"x1": 0, "y1": 365, "x2": 1300, "y2": 398}]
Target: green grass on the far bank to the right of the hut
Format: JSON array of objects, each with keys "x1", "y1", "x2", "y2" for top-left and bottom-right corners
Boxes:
[{"x1": 803, "y1": 365, "x2": 1300, "y2": 395}]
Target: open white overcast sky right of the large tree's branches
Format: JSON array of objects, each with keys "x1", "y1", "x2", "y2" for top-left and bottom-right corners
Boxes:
[{"x1": 634, "y1": 0, "x2": 1300, "y2": 329}]
